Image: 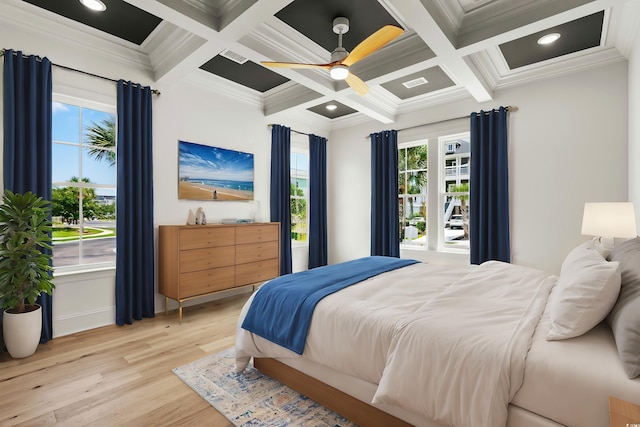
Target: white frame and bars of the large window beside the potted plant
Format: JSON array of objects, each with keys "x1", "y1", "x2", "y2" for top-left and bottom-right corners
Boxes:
[{"x1": 51, "y1": 92, "x2": 118, "y2": 276}]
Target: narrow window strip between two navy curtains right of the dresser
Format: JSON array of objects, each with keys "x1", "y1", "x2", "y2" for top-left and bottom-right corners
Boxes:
[{"x1": 290, "y1": 146, "x2": 309, "y2": 244}]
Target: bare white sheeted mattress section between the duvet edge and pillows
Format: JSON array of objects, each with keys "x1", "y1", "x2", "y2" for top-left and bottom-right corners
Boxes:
[{"x1": 511, "y1": 304, "x2": 640, "y2": 427}]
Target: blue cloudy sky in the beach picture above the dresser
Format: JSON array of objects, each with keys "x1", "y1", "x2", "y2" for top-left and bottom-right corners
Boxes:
[{"x1": 178, "y1": 141, "x2": 253, "y2": 182}]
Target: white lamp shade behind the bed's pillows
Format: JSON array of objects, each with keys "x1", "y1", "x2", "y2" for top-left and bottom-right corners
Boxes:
[{"x1": 582, "y1": 202, "x2": 637, "y2": 238}]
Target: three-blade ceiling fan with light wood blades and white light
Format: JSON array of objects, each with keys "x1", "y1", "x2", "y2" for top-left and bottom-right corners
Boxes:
[{"x1": 262, "y1": 17, "x2": 404, "y2": 96}]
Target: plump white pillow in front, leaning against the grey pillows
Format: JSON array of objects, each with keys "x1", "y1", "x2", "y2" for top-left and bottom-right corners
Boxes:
[{"x1": 547, "y1": 241, "x2": 620, "y2": 341}]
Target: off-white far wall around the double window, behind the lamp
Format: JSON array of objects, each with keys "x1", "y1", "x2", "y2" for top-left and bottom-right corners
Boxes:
[{"x1": 327, "y1": 62, "x2": 628, "y2": 273}]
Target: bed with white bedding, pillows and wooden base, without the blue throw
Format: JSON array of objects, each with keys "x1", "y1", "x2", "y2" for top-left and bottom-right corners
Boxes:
[{"x1": 236, "y1": 238, "x2": 640, "y2": 427}]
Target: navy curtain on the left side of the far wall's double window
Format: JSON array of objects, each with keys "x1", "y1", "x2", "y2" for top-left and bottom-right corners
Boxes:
[{"x1": 371, "y1": 130, "x2": 400, "y2": 257}]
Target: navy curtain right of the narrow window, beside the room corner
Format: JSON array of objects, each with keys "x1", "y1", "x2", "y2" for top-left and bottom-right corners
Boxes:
[{"x1": 308, "y1": 135, "x2": 328, "y2": 268}]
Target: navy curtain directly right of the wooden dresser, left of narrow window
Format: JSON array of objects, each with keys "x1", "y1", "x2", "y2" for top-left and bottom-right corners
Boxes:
[{"x1": 270, "y1": 125, "x2": 292, "y2": 275}]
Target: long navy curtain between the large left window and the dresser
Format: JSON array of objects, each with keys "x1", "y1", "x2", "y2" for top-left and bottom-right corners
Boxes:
[{"x1": 116, "y1": 80, "x2": 155, "y2": 325}]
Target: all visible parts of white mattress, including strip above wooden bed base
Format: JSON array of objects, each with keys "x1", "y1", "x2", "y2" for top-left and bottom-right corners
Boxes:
[{"x1": 272, "y1": 313, "x2": 640, "y2": 427}]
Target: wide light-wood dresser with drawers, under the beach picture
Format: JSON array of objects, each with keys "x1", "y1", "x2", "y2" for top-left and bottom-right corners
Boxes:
[{"x1": 158, "y1": 222, "x2": 280, "y2": 321}]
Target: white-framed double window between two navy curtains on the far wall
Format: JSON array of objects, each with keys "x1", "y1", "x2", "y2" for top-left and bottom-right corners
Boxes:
[{"x1": 398, "y1": 132, "x2": 471, "y2": 253}]
